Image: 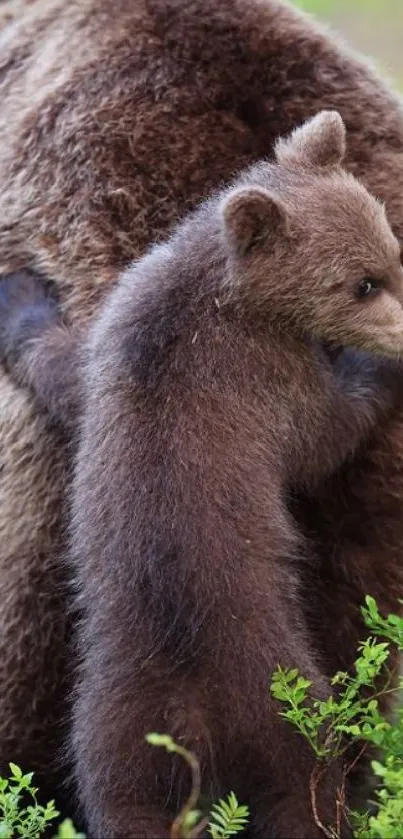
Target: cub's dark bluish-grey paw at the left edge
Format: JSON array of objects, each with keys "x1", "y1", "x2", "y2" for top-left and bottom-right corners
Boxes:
[{"x1": 0, "y1": 269, "x2": 59, "y2": 366}]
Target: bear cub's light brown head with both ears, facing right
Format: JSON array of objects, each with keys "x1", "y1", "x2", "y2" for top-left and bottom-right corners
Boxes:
[{"x1": 220, "y1": 111, "x2": 403, "y2": 355}]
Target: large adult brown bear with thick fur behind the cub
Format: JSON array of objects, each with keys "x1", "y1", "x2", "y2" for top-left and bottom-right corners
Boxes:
[{"x1": 0, "y1": 0, "x2": 403, "y2": 812}]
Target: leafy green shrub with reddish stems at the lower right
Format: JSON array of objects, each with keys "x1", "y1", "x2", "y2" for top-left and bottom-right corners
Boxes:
[{"x1": 271, "y1": 597, "x2": 403, "y2": 839}]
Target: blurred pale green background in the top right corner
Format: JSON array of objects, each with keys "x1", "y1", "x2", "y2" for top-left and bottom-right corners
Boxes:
[{"x1": 293, "y1": 0, "x2": 403, "y2": 90}]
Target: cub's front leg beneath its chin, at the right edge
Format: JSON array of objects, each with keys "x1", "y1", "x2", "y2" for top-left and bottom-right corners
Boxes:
[{"x1": 294, "y1": 348, "x2": 403, "y2": 493}]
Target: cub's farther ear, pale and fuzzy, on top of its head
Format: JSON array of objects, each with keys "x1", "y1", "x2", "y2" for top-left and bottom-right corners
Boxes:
[{"x1": 275, "y1": 111, "x2": 346, "y2": 168}]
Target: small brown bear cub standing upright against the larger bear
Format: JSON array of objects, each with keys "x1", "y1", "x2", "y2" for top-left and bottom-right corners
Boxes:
[{"x1": 0, "y1": 111, "x2": 403, "y2": 839}]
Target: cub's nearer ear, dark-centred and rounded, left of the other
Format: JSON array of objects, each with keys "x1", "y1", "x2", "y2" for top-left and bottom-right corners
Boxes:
[{"x1": 221, "y1": 187, "x2": 287, "y2": 256}]
